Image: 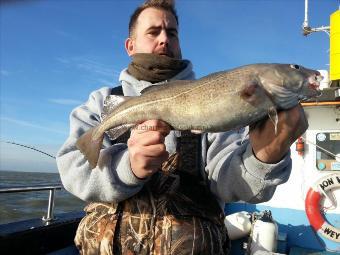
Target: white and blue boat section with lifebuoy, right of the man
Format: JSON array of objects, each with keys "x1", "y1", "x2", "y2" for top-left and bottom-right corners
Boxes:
[{"x1": 225, "y1": 0, "x2": 340, "y2": 255}]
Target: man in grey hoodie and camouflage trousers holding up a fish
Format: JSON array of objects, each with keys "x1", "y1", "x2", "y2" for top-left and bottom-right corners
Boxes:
[{"x1": 57, "y1": 0, "x2": 307, "y2": 254}]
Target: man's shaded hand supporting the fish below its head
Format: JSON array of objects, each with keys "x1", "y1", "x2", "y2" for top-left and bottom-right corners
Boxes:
[{"x1": 249, "y1": 105, "x2": 308, "y2": 163}]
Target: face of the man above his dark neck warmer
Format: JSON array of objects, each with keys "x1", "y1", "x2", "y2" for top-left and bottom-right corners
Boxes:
[{"x1": 125, "y1": 8, "x2": 182, "y2": 59}]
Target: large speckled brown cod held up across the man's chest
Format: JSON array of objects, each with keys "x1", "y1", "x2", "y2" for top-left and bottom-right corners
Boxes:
[{"x1": 77, "y1": 64, "x2": 322, "y2": 168}]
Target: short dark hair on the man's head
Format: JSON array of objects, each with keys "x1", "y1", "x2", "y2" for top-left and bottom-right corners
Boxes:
[{"x1": 129, "y1": 0, "x2": 178, "y2": 37}]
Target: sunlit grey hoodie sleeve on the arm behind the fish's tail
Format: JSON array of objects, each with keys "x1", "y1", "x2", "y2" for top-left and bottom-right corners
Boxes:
[{"x1": 57, "y1": 88, "x2": 145, "y2": 202}]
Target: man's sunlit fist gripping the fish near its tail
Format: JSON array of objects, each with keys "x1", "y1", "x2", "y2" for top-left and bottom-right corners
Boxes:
[{"x1": 127, "y1": 120, "x2": 170, "y2": 179}]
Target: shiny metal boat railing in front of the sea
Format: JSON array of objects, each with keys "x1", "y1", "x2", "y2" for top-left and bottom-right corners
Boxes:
[{"x1": 0, "y1": 184, "x2": 64, "y2": 223}]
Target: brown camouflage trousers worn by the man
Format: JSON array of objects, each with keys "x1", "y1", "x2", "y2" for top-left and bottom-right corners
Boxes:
[{"x1": 75, "y1": 197, "x2": 229, "y2": 255}]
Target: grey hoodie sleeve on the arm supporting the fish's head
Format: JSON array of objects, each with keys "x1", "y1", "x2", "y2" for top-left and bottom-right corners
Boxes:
[{"x1": 205, "y1": 128, "x2": 292, "y2": 203}]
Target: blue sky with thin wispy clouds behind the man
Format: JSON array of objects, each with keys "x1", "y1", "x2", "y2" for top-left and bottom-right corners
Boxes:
[{"x1": 0, "y1": 0, "x2": 339, "y2": 172}]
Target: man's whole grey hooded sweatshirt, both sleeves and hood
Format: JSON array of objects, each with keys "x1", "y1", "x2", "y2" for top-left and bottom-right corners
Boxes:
[{"x1": 57, "y1": 63, "x2": 291, "y2": 206}]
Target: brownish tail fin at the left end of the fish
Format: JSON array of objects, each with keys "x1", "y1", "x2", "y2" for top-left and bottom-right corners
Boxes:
[{"x1": 76, "y1": 127, "x2": 104, "y2": 169}]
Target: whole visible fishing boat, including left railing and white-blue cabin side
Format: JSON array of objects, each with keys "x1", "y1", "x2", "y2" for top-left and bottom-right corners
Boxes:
[{"x1": 0, "y1": 0, "x2": 340, "y2": 255}]
